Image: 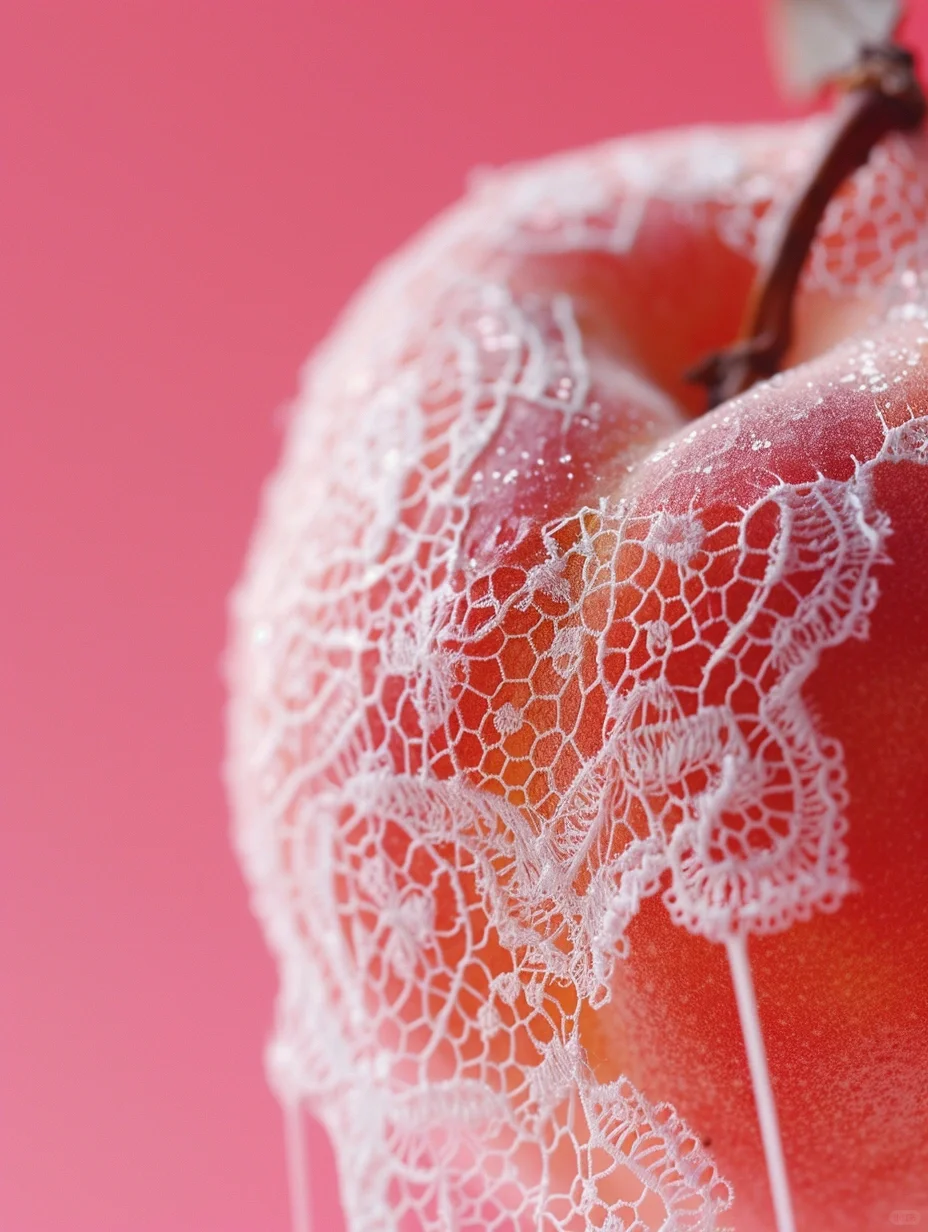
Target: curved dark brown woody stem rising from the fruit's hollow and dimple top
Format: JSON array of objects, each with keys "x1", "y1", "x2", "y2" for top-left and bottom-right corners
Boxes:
[{"x1": 686, "y1": 44, "x2": 926, "y2": 410}]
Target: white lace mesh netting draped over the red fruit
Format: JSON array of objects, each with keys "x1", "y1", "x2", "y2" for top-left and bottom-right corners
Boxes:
[{"x1": 223, "y1": 122, "x2": 928, "y2": 1232}]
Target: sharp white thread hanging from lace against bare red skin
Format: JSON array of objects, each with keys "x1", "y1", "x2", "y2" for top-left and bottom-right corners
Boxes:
[{"x1": 726, "y1": 936, "x2": 796, "y2": 1232}]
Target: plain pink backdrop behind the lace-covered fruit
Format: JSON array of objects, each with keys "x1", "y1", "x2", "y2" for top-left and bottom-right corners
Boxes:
[{"x1": 0, "y1": 0, "x2": 928, "y2": 1232}]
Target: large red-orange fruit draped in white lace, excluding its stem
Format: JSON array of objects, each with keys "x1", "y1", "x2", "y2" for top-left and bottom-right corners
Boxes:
[{"x1": 228, "y1": 123, "x2": 928, "y2": 1232}]
